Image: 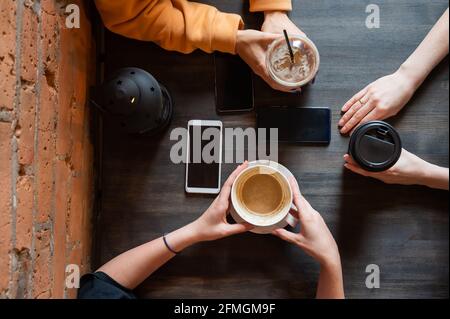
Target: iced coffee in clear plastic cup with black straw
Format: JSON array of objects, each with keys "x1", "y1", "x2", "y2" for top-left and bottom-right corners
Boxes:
[{"x1": 266, "y1": 35, "x2": 320, "y2": 90}]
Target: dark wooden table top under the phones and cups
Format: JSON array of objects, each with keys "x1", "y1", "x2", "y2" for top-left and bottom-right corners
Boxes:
[{"x1": 93, "y1": 0, "x2": 449, "y2": 298}]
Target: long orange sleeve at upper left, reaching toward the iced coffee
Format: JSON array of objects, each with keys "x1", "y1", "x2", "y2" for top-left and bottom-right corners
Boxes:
[{"x1": 95, "y1": 0, "x2": 243, "y2": 54}]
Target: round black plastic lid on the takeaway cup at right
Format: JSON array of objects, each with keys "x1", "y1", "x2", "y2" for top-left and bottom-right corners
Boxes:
[{"x1": 348, "y1": 121, "x2": 402, "y2": 172}]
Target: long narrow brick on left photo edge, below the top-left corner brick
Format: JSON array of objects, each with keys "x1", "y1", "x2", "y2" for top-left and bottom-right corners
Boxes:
[{"x1": 0, "y1": 122, "x2": 11, "y2": 295}]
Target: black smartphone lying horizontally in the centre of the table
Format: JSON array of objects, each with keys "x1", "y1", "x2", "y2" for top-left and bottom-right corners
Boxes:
[{"x1": 256, "y1": 106, "x2": 331, "y2": 144}]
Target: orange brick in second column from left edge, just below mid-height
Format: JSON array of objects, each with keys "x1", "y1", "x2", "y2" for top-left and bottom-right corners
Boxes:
[{"x1": 15, "y1": 175, "x2": 34, "y2": 250}]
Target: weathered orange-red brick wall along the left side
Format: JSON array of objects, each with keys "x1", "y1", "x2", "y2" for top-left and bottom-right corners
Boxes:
[{"x1": 0, "y1": 0, "x2": 93, "y2": 298}]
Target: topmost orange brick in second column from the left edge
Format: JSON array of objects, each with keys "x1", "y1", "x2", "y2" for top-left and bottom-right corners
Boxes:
[{"x1": 20, "y1": 6, "x2": 39, "y2": 82}]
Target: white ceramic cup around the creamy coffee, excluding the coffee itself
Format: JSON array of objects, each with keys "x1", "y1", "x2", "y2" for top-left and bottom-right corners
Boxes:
[{"x1": 230, "y1": 163, "x2": 298, "y2": 234}]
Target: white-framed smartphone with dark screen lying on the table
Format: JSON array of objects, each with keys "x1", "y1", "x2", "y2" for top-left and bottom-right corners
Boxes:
[{"x1": 185, "y1": 120, "x2": 222, "y2": 194}]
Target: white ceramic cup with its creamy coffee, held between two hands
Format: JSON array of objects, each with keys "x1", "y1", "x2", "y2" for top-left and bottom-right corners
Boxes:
[{"x1": 231, "y1": 162, "x2": 297, "y2": 233}]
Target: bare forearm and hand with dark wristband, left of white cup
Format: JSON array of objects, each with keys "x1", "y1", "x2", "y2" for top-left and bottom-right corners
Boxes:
[{"x1": 97, "y1": 163, "x2": 251, "y2": 289}]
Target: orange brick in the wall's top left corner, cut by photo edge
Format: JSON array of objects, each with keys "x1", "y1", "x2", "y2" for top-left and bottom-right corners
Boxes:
[{"x1": 0, "y1": 0, "x2": 16, "y2": 110}]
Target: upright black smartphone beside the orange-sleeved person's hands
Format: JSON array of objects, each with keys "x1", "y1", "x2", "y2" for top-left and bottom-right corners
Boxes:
[{"x1": 214, "y1": 53, "x2": 253, "y2": 114}]
